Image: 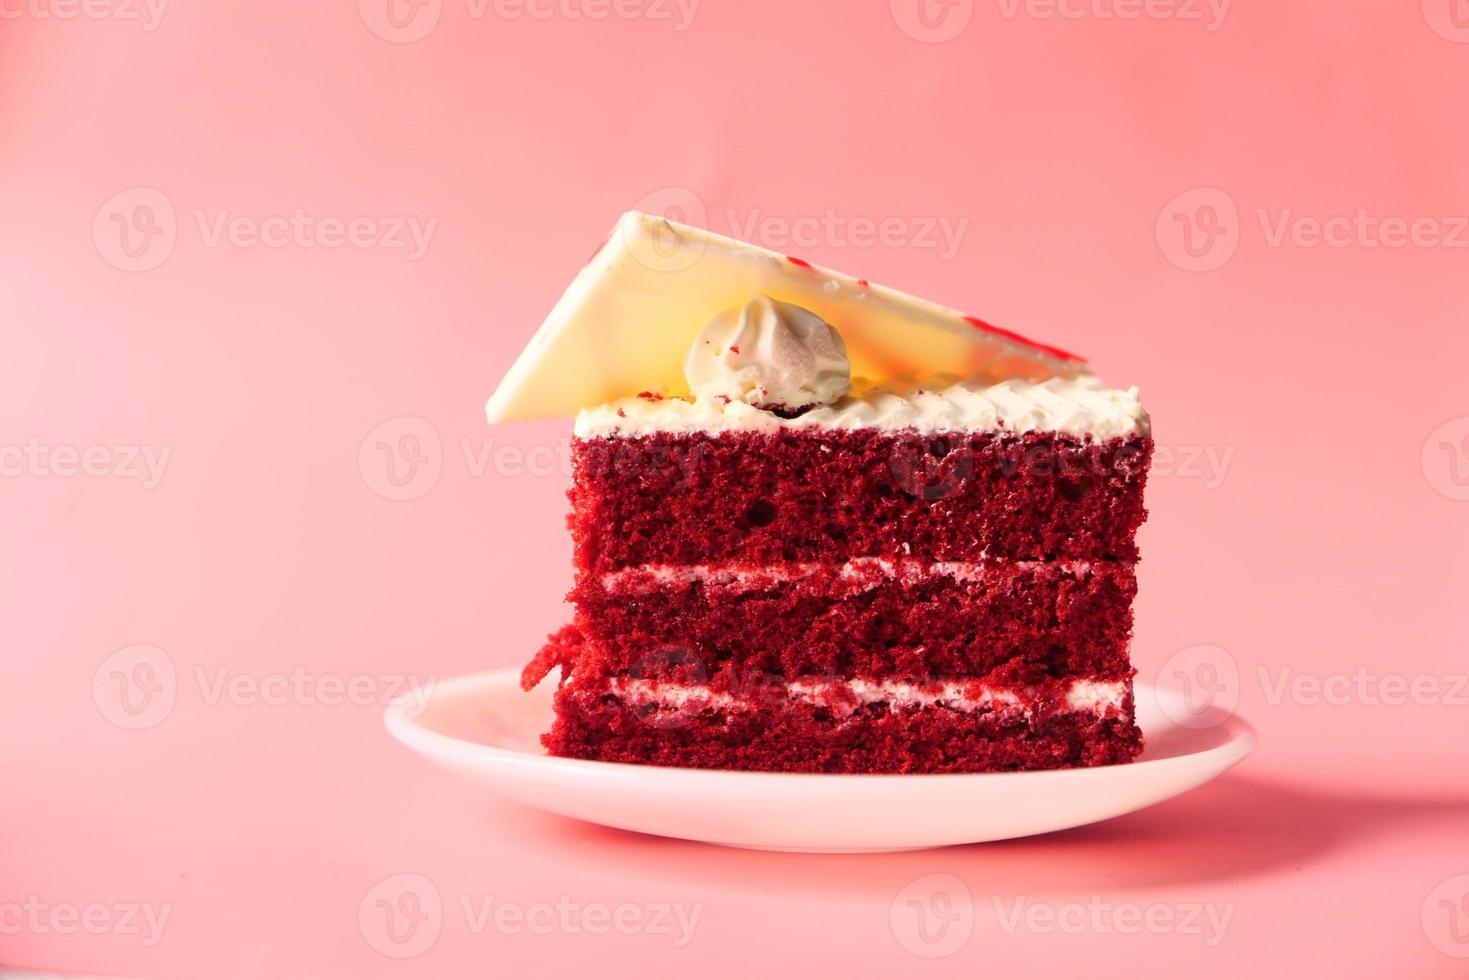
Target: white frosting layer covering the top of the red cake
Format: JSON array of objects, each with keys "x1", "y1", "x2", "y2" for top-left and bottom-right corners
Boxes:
[{"x1": 576, "y1": 375, "x2": 1152, "y2": 439}]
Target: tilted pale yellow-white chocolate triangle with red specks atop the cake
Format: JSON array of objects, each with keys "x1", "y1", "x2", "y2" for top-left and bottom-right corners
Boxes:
[{"x1": 485, "y1": 212, "x2": 1086, "y2": 422}]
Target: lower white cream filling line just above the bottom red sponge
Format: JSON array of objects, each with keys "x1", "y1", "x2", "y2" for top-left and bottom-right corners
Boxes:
[{"x1": 610, "y1": 677, "x2": 1131, "y2": 716}]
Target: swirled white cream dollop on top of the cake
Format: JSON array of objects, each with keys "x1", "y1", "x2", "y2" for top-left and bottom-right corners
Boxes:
[{"x1": 683, "y1": 295, "x2": 852, "y2": 408}]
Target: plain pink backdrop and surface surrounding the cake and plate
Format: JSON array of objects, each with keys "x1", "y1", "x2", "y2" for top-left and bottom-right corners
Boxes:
[{"x1": 0, "y1": 0, "x2": 1469, "y2": 977}]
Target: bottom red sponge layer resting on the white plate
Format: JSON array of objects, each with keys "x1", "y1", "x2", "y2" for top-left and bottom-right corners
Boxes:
[{"x1": 545, "y1": 667, "x2": 1141, "y2": 773}]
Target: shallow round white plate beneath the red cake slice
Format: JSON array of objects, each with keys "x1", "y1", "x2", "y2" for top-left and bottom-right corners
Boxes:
[{"x1": 386, "y1": 670, "x2": 1255, "y2": 852}]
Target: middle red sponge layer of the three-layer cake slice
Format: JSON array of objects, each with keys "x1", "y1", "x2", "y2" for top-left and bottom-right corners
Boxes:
[{"x1": 571, "y1": 560, "x2": 1137, "y2": 683}]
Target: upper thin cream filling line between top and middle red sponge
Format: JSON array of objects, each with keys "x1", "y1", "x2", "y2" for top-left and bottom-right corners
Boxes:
[{"x1": 601, "y1": 558, "x2": 1093, "y2": 592}]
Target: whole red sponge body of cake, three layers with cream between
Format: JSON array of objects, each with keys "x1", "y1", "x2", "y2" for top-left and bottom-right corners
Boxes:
[{"x1": 524, "y1": 429, "x2": 1153, "y2": 773}]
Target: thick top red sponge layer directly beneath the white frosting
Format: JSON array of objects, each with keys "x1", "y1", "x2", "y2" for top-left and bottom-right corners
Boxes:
[{"x1": 570, "y1": 429, "x2": 1153, "y2": 573}]
